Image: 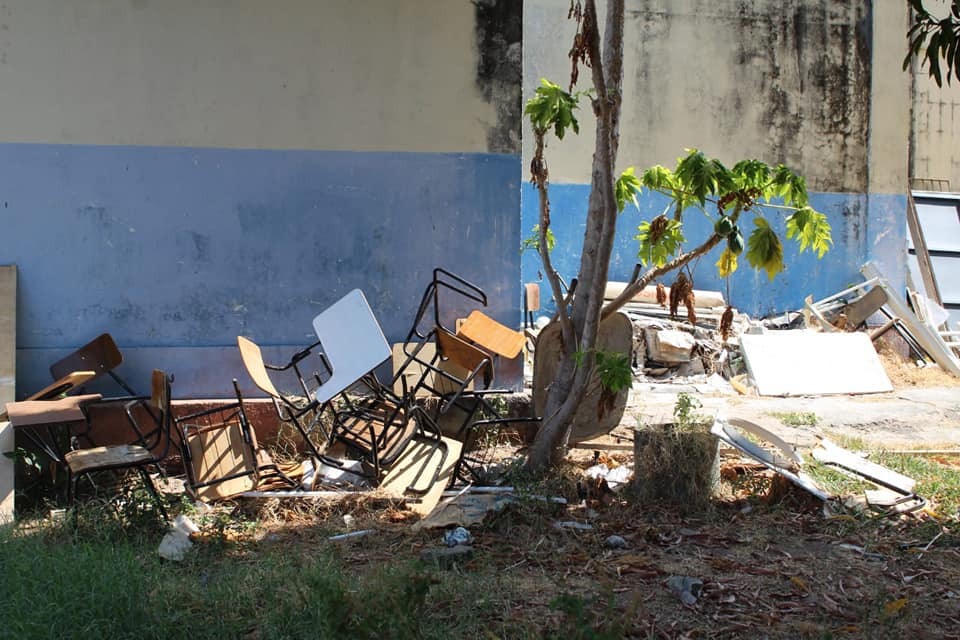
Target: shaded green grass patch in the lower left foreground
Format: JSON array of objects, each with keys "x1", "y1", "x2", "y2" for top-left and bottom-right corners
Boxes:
[{"x1": 0, "y1": 504, "x2": 539, "y2": 639}]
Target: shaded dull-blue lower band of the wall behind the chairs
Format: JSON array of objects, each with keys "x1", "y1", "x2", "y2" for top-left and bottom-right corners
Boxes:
[{"x1": 0, "y1": 144, "x2": 520, "y2": 397}]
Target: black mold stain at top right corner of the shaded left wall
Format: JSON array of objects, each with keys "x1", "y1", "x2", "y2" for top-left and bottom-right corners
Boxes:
[{"x1": 473, "y1": 0, "x2": 523, "y2": 153}]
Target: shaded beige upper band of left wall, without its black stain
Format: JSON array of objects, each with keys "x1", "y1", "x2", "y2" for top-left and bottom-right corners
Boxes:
[{"x1": 0, "y1": 0, "x2": 497, "y2": 152}]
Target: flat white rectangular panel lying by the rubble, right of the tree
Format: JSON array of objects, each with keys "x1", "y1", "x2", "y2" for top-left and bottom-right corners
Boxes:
[{"x1": 740, "y1": 330, "x2": 893, "y2": 396}]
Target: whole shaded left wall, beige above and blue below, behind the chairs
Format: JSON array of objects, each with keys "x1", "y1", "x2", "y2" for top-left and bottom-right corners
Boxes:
[{"x1": 0, "y1": 0, "x2": 521, "y2": 397}]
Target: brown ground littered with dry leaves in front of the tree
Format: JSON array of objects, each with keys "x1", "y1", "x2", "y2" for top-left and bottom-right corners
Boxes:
[{"x1": 231, "y1": 460, "x2": 960, "y2": 638}]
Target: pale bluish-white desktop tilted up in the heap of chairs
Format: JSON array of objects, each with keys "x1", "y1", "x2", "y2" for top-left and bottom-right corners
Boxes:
[{"x1": 313, "y1": 289, "x2": 390, "y2": 404}]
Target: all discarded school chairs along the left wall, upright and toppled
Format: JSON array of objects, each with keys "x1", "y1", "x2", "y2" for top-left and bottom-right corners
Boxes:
[{"x1": 0, "y1": 268, "x2": 536, "y2": 515}]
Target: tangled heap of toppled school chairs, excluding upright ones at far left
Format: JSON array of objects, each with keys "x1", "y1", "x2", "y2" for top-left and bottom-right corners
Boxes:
[{"x1": 176, "y1": 268, "x2": 524, "y2": 508}]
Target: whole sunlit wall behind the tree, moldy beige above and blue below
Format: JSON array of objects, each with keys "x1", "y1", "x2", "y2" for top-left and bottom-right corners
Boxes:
[{"x1": 522, "y1": 0, "x2": 909, "y2": 314}]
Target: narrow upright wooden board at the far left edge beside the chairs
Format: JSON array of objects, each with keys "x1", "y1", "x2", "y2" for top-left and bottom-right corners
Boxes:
[{"x1": 0, "y1": 265, "x2": 17, "y2": 524}]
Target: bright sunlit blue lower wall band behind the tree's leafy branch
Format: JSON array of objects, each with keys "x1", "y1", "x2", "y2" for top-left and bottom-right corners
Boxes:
[{"x1": 521, "y1": 184, "x2": 906, "y2": 317}]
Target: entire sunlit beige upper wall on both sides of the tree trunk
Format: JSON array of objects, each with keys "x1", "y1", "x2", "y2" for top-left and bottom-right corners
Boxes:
[{"x1": 524, "y1": 0, "x2": 909, "y2": 192}]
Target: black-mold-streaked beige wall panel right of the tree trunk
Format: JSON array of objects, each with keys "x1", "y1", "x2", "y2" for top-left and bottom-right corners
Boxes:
[{"x1": 628, "y1": 0, "x2": 872, "y2": 193}]
